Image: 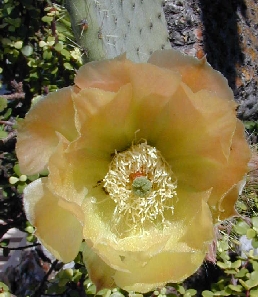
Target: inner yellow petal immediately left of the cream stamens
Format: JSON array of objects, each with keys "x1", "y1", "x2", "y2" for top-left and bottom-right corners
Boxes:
[{"x1": 48, "y1": 139, "x2": 111, "y2": 205}]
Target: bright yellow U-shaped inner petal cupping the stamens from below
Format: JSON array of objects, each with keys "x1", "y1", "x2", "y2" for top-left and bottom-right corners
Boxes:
[{"x1": 82, "y1": 187, "x2": 214, "y2": 282}]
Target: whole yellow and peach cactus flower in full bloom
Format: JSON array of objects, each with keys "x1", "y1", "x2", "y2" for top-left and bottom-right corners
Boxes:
[{"x1": 16, "y1": 50, "x2": 250, "y2": 293}]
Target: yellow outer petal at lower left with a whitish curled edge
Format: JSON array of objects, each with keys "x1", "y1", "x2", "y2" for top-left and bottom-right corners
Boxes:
[{"x1": 24, "y1": 179, "x2": 82, "y2": 262}]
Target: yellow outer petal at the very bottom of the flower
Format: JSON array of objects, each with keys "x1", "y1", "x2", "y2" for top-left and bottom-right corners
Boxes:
[{"x1": 114, "y1": 251, "x2": 205, "y2": 293}]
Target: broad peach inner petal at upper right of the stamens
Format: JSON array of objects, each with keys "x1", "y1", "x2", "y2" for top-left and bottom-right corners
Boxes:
[{"x1": 156, "y1": 84, "x2": 236, "y2": 164}]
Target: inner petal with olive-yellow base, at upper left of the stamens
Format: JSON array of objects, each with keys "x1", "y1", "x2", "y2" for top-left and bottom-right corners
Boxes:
[{"x1": 70, "y1": 85, "x2": 137, "y2": 153}]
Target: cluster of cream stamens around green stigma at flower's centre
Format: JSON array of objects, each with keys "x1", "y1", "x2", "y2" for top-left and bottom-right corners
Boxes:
[{"x1": 103, "y1": 142, "x2": 177, "y2": 229}]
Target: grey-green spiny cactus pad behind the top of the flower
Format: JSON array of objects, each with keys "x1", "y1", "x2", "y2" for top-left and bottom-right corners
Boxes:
[{"x1": 67, "y1": 0, "x2": 170, "y2": 62}]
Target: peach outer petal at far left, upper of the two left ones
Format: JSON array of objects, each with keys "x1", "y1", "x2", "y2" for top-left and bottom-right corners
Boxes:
[{"x1": 16, "y1": 88, "x2": 78, "y2": 174}]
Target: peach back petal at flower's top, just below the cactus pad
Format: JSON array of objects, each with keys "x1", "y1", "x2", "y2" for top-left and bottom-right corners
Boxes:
[{"x1": 74, "y1": 55, "x2": 181, "y2": 98}]
